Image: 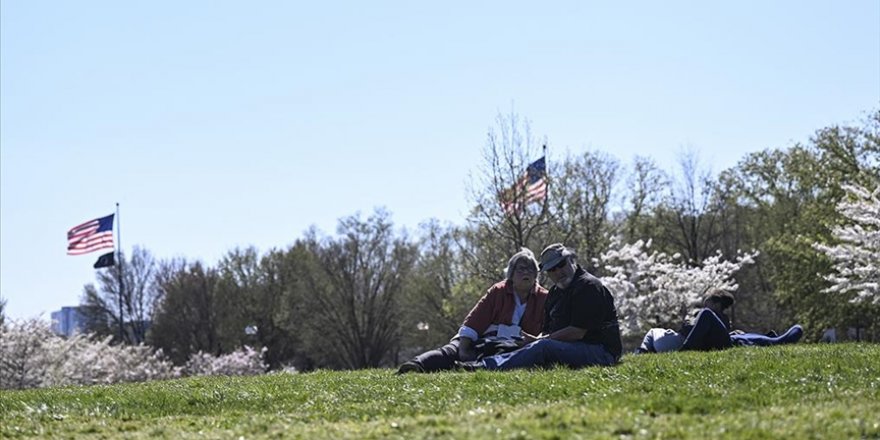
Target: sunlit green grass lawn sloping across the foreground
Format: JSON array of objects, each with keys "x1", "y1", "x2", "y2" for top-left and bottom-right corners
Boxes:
[{"x1": 0, "y1": 344, "x2": 880, "y2": 439}]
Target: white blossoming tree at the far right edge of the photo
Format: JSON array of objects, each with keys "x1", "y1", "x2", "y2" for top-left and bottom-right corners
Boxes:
[{"x1": 814, "y1": 185, "x2": 880, "y2": 305}]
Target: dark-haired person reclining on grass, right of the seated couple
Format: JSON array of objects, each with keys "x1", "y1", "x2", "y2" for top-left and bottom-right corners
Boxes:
[{"x1": 636, "y1": 290, "x2": 804, "y2": 353}]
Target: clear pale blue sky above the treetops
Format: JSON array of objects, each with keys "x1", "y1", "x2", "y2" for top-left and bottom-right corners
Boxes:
[{"x1": 0, "y1": 0, "x2": 880, "y2": 318}]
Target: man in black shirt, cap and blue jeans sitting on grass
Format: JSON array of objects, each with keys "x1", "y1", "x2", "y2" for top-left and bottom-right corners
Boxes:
[{"x1": 458, "y1": 243, "x2": 622, "y2": 371}]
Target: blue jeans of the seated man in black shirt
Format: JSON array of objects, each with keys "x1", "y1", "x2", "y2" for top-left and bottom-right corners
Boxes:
[{"x1": 483, "y1": 338, "x2": 617, "y2": 370}]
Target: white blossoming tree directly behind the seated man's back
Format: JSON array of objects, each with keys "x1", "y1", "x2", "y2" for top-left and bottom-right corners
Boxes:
[{"x1": 594, "y1": 239, "x2": 757, "y2": 336}]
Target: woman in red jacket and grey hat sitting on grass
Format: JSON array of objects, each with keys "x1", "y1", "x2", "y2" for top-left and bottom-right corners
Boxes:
[{"x1": 397, "y1": 248, "x2": 547, "y2": 374}]
